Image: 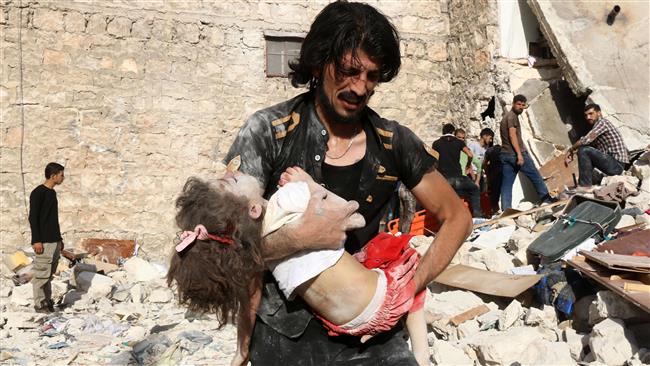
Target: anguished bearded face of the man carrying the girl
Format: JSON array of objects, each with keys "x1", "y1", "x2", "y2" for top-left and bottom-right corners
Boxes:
[{"x1": 317, "y1": 50, "x2": 380, "y2": 124}]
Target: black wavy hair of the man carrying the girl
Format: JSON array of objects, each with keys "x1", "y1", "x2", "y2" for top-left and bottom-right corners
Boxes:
[{"x1": 289, "y1": 1, "x2": 401, "y2": 90}]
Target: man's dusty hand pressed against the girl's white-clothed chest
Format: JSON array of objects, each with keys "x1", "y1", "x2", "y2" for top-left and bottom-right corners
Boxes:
[{"x1": 287, "y1": 189, "x2": 366, "y2": 249}]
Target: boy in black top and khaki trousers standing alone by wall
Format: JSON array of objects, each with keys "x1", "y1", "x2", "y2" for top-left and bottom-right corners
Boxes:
[{"x1": 29, "y1": 163, "x2": 65, "y2": 313}]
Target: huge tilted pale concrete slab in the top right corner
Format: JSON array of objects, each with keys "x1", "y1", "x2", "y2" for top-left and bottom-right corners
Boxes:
[{"x1": 528, "y1": 0, "x2": 650, "y2": 149}]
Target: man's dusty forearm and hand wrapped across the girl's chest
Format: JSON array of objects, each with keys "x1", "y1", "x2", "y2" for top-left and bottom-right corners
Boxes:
[{"x1": 262, "y1": 189, "x2": 359, "y2": 261}]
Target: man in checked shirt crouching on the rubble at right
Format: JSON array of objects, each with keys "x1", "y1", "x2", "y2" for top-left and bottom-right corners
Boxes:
[{"x1": 566, "y1": 104, "x2": 629, "y2": 188}]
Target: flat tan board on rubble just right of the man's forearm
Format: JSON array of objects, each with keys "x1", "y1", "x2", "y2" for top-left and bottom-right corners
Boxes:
[{"x1": 434, "y1": 264, "x2": 543, "y2": 297}]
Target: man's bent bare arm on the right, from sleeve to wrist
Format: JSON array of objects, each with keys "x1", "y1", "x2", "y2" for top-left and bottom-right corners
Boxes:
[{"x1": 412, "y1": 171, "x2": 472, "y2": 291}]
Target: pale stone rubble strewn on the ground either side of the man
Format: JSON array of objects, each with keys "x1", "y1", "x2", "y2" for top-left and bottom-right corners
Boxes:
[{"x1": 0, "y1": 153, "x2": 650, "y2": 365}]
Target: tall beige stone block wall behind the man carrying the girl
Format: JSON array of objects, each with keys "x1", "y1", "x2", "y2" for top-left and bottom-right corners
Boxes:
[{"x1": 0, "y1": 0, "x2": 466, "y2": 258}]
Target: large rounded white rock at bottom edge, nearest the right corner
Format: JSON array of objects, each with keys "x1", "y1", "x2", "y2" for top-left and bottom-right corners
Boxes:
[{"x1": 589, "y1": 318, "x2": 638, "y2": 365}]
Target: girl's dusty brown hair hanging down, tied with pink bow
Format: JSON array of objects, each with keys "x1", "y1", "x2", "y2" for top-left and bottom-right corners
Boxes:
[{"x1": 167, "y1": 178, "x2": 264, "y2": 328}]
